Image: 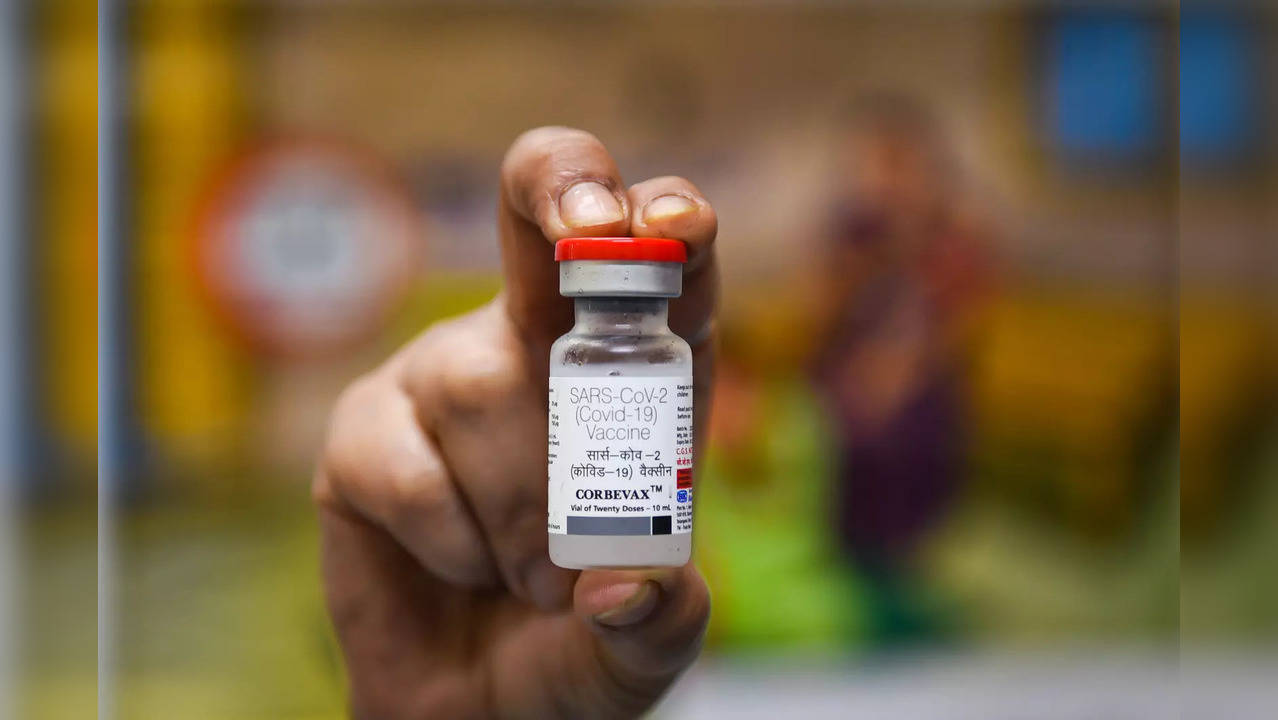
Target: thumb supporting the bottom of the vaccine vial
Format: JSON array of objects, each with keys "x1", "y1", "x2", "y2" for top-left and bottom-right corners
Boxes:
[{"x1": 573, "y1": 563, "x2": 711, "y2": 705}]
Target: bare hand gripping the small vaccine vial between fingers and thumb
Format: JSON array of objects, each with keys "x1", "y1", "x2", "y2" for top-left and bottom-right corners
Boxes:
[{"x1": 313, "y1": 128, "x2": 718, "y2": 719}]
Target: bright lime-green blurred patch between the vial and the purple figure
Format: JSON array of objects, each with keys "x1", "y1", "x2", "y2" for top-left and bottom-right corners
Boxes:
[{"x1": 695, "y1": 382, "x2": 865, "y2": 653}]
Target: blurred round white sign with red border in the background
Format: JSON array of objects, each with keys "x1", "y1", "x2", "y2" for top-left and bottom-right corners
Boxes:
[{"x1": 194, "y1": 141, "x2": 423, "y2": 357}]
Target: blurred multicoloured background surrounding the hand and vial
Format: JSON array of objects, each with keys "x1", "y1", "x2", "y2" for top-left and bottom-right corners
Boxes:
[{"x1": 0, "y1": 0, "x2": 1278, "y2": 719}]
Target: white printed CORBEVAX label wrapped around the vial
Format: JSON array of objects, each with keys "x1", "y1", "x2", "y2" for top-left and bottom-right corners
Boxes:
[{"x1": 547, "y1": 376, "x2": 693, "y2": 535}]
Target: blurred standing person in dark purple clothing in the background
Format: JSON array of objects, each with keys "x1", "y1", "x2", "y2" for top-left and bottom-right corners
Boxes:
[{"x1": 814, "y1": 92, "x2": 989, "y2": 637}]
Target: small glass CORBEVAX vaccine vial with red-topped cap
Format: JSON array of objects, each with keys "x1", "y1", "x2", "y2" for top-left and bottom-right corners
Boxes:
[{"x1": 547, "y1": 238, "x2": 693, "y2": 569}]
